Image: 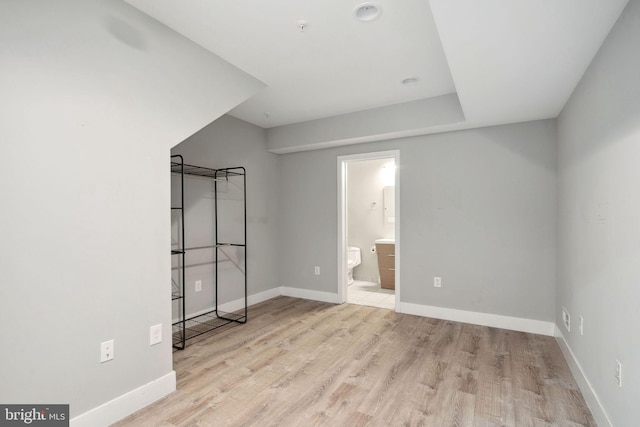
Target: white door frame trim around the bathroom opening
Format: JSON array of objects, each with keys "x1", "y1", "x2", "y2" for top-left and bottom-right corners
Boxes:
[{"x1": 337, "y1": 150, "x2": 402, "y2": 311}]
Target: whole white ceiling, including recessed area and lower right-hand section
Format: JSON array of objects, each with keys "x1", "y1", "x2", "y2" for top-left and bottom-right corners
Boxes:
[{"x1": 126, "y1": 0, "x2": 628, "y2": 128}]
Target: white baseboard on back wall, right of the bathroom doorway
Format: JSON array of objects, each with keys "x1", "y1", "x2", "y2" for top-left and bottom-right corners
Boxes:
[{"x1": 396, "y1": 302, "x2": 556, "y2": 336}]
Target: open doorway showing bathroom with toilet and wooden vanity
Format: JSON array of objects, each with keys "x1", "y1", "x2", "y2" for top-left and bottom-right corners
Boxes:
[{"x1": 337, "y1": 150, "x2": 400, "y2": 310}]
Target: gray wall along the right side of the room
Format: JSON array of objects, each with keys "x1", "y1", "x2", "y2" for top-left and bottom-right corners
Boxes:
[{"x1": 556, "y1": 0, "x2": 640, "y2": 426}]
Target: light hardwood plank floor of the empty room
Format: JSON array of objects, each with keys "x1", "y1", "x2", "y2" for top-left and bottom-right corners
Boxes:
[{"x1": 116, "y1": 297, "x2": 596, "y2": 427}]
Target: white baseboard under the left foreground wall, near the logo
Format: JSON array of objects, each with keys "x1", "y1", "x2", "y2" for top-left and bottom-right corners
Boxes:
[{"x1": 69, "y1": 371, "x2": 176, "y2": 427}]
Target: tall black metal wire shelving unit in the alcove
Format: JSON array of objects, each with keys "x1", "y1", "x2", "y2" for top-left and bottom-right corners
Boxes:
[{"x1": 171, "y1": 155, "x2": 247, "y2": 350}]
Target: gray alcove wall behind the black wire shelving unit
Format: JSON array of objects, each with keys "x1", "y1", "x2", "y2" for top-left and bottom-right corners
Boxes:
[{"x1": 171, "y1": 116, "x2": 279, "y2": 313}]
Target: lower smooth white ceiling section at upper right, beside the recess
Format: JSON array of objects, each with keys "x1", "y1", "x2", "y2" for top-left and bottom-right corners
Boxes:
[{"x1": 431, "y1": 0, "x2": 628, "y2": 124}]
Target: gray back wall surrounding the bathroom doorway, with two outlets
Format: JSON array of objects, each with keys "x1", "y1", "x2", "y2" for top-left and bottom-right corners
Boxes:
[{"x1": 279, "y1": 120, "x2": 556, "y2": 321}]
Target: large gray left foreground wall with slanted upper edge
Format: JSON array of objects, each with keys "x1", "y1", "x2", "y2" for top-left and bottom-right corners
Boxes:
[{"x1": 0, "y1": 0, "x2": 257, "y2": 423}]
